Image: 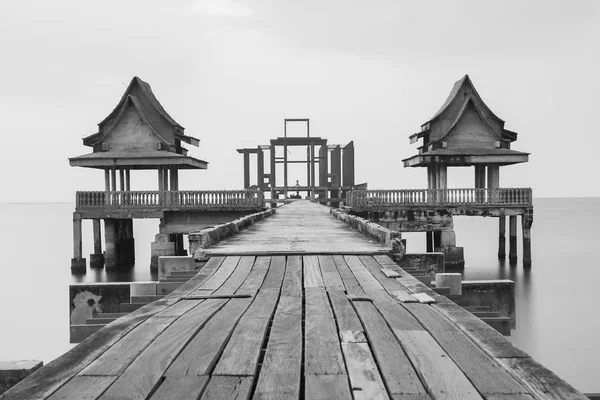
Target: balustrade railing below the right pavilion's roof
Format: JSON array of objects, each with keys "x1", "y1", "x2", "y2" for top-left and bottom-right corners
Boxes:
[{"x1": 346, "y1": 188, "x2": 532, "y2": 209}]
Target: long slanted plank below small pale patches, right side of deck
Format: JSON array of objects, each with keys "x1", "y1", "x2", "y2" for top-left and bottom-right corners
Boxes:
[{"x1": 405, "y1": 304, "x2": 528, "y2": 397}]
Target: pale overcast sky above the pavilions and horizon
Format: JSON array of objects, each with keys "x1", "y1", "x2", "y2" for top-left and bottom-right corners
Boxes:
[{"x1": 0, "y1": 0, "x2": 600, "y2": 202}]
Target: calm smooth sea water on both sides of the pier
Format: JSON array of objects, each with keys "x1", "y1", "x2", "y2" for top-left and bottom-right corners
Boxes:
[{"x1": 0, "y1": 198, "x2": 600, "y2": 392}]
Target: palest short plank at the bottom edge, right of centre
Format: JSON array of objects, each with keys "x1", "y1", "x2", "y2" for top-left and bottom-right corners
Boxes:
[{"x1": 342, "y1": 343, "x2": 389, "y2": 400}]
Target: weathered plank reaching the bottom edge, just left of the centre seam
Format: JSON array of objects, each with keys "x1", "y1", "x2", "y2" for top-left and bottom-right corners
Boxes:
[{"x1": 254, "y1": 296, "x2": 302, "y2": 399}]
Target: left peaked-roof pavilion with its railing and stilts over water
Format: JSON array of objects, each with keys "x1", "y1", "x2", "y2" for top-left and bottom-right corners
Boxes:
[{"x1": 69, "y1": 77, "x2": 262, "y2": 271}]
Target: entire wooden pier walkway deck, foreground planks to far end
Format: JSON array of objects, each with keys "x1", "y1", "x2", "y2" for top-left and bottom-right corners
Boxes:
[{"x1": 1, "y1": 201, "x2": 585, "y2": 399}]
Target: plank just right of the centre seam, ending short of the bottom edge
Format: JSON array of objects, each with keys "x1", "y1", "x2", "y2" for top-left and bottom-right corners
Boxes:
[{"x1": 304, "y1": 288, "x2": 346, "y2": 375}]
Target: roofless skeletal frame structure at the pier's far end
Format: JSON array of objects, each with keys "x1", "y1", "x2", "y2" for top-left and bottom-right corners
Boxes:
[{"x1": 237, "y1": 118, "x2": 354, "y2": 207}]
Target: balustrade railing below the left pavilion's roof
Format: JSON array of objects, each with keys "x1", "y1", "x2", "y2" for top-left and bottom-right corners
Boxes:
[{"x1": 75, "y1": 190, "x2": 264, "y2": 210}]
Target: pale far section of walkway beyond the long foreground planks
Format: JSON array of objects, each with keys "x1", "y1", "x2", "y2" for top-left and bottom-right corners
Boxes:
[{"x1": 205, "y1": 200, "x2": 391, "y2": 255}]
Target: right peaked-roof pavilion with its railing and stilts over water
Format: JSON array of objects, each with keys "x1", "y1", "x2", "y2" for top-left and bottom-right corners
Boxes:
[{"x1": 347, "y1": 75, "x2": 533, "y2": 267}]
